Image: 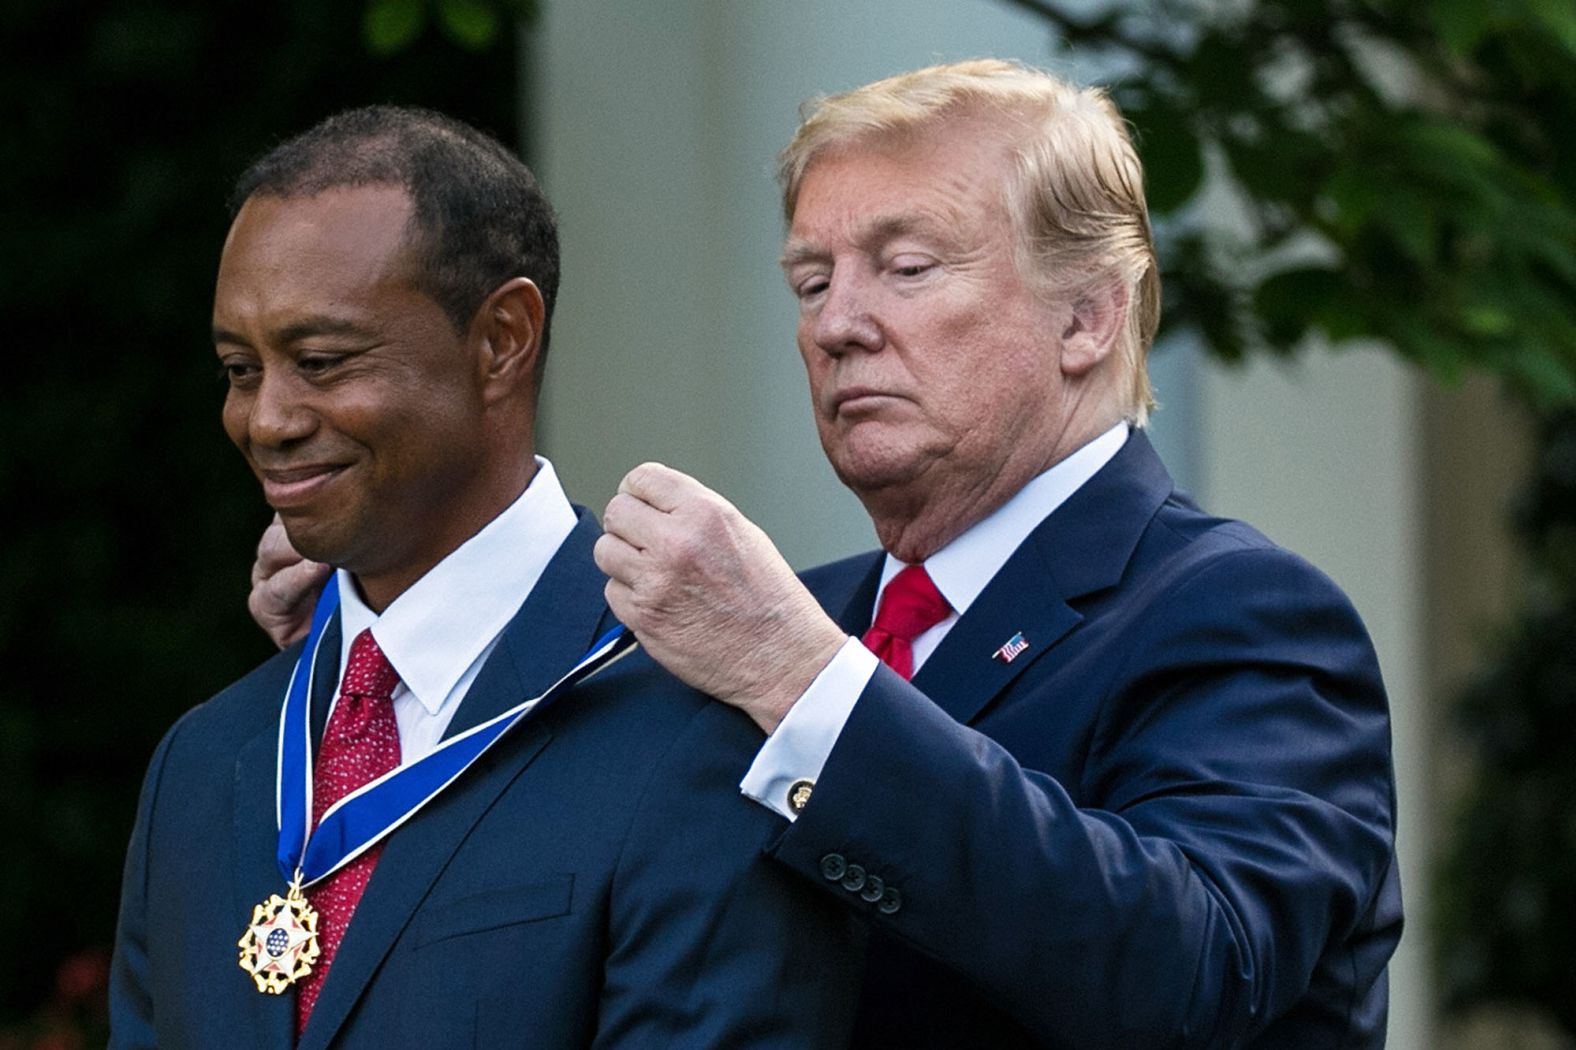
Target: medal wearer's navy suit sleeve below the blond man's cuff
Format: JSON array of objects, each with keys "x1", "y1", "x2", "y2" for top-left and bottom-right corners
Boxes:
[{"x1": 594, "y1": 693, "x2": 865, "y2": 1050}]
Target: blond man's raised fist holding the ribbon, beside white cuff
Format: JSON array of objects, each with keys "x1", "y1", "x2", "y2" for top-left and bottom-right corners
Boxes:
[{"x1": 596, "y1": 464, "x2": 848, "y2": 733}]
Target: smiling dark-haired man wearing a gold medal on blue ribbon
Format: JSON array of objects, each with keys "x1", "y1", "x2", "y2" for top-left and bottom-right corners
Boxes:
[{"x1": 110, "y1": 107, "x2": 857, "y2": 1050}]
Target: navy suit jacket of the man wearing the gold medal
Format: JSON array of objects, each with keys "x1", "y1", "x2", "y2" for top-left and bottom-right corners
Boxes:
[{"x1": 110, "y1": 512, "x2": 859, "y2": 1050}]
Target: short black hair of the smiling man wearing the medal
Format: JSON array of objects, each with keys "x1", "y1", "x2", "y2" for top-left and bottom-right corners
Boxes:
[{"x1": 230, "y1": 106, "x2": 558, "y2": 362}]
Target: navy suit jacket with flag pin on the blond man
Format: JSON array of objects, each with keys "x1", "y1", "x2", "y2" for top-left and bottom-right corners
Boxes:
[{"x1": 771, "y1": 434, "x2": 1401, "y2": 1050}]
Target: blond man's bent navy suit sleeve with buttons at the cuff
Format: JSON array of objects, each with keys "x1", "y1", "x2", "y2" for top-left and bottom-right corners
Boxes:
[{"x1": 771, "y1": 549, "x2": 1398, "y2": 1047}]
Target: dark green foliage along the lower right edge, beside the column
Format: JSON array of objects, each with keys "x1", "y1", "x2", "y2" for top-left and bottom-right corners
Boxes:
[{"x1": 1436, "y1": 411, "x2": 1576, "y2": 1034}]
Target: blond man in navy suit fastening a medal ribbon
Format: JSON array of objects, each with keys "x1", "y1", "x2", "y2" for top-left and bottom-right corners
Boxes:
[{"x1": 258, "y1": 61, "x2": 1401, "y2": 1050}]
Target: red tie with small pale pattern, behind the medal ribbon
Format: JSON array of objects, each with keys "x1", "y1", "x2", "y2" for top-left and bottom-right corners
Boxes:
[{"x1": 296, "y1": 631, "x2": 399, "y2": 1037}]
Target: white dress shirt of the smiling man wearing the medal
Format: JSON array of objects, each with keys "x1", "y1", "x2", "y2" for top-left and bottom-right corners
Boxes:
[{"x1": 336, "y1": 456, "x2": 575, "y2": 765}]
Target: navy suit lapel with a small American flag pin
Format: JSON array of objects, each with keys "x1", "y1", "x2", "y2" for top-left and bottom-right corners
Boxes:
[{"x1": 914, "y1": 430, "x2": 1171, "y2": 724}]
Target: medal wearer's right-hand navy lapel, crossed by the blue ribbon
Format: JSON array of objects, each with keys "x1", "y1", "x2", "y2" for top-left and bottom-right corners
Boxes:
[{"x1": 299, "y1": 512, "x2": 610, "y2": 1050}]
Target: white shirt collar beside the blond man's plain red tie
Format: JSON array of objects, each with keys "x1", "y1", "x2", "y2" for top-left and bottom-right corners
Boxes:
[{"x1": 881, "y1": 423, "x2": 1127, "y2": 616}]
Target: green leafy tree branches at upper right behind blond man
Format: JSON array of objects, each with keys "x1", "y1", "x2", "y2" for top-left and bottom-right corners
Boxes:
[{"x1": 1013, "y1": 0, "x2": 1576, "y2": 410}]
